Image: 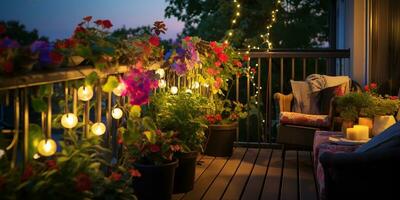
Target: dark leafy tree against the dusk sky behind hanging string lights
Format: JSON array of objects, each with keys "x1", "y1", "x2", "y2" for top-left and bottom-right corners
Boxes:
[{"x1": 165, "y1": 0, "x2": 331, "y2": 48}]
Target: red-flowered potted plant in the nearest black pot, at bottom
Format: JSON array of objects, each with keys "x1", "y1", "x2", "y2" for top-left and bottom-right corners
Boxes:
[{"x1": 119, "y1": 105, "x2": 181, "y2": 199}]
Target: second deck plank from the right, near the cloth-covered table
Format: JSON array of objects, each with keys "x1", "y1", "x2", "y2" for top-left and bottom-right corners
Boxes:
[{"x1": 281, "y1": 151, "x2": 298, "y2": 200}]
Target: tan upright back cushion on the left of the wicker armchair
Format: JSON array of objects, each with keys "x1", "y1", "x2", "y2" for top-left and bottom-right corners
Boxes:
[{"x1": 290, "y1": 80, "x2": 320, "y2": 114}]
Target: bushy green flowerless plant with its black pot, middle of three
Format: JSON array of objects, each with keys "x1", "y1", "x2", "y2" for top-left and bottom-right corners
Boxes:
[{"x1": 148, "y1": 91, "x2": 208, "y2": 193}]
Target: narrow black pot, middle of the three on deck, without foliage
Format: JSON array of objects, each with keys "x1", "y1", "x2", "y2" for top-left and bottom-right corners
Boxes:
[{"x1": 174, "y1": 151, "x2": 199, "y2": 194}]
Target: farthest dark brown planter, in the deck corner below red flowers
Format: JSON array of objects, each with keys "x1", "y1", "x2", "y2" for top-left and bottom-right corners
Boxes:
[{"x1": 204, "y1": 123, "x2": 238, "y2": 157}]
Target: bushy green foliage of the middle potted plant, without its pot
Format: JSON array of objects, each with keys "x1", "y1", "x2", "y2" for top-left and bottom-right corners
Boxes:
[{"x1": 148, "y1": 92, "x2": 210, "y2": 152}]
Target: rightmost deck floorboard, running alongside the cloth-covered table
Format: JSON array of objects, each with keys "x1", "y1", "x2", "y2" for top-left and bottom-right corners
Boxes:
[{"x1": 298, "y1": 151, "x2": 317, "y2": 200}]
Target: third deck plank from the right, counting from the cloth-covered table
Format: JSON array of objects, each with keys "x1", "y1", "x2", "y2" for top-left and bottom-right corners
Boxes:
[{"x1": 261, "y1": 149, "x2": 282, "y2": 200}]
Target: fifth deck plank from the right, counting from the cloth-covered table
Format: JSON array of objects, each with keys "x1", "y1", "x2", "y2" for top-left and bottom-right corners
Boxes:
[{"x1": 222, "y1": 149, "x2": 259, "y2": 200}]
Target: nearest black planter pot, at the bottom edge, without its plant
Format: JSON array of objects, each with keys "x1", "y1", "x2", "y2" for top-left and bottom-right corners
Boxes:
[{"x1": 133, "y1": 160, "x2": 178, "y2": 200}]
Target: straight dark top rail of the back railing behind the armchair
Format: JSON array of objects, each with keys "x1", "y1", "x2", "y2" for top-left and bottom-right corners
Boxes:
[{"x1": 240, "y1": 49, "x2": 350, "y2": 58}]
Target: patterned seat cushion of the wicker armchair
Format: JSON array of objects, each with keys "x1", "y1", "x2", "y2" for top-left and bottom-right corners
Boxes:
[{"x1": 279, "y1": 112, "x2": 330, "y2": 128}]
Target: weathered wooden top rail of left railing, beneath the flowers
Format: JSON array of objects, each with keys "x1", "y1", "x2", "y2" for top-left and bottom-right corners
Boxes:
[{"x1": 0, "y1": 65, "x2": 128, "y2": 91}]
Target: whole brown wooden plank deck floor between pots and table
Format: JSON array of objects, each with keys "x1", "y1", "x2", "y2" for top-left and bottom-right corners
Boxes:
[{"x1": 173, "y1": 148, "x2": 317, "y2": 200}]
